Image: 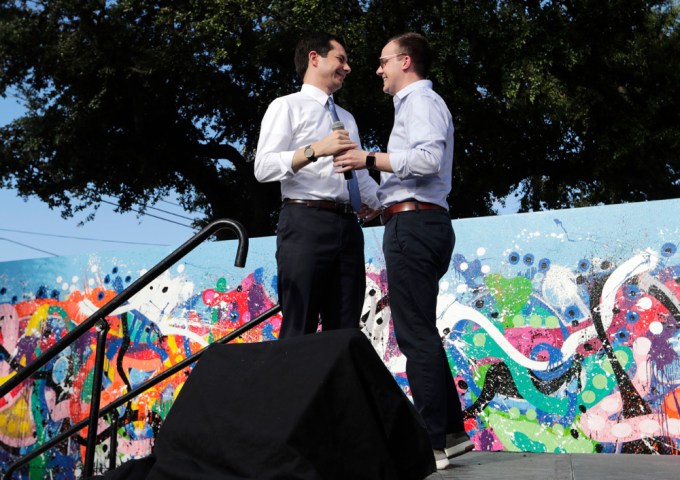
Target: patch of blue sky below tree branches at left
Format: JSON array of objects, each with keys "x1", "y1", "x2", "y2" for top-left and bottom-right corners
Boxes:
[{"x1": 0, "y1": 93, "x2": 195, "y2": 262}]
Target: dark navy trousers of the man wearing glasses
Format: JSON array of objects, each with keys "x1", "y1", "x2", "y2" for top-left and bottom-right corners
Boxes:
[{"x1": 383, "y1": 210, "x2": 464, "y2": 449}]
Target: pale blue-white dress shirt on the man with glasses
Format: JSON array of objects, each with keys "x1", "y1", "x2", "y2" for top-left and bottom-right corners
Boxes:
[{"x1": 378, "y1": 80, "x2": 453, "y2": 210}]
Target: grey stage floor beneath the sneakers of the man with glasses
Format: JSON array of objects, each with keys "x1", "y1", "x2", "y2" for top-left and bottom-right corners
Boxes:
[{"x1": 426, "y1": 452, "x2": 680, "y2": 480}]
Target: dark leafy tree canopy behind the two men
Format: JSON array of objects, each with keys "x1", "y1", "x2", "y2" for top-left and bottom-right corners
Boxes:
[{"x1": 0, "y1": 0, "x2": 680, "y2": 236}]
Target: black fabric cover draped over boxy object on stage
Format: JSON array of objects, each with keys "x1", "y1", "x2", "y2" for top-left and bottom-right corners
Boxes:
[{"x1": 94, "y1": 330, "x2": 435, "y2": 480}]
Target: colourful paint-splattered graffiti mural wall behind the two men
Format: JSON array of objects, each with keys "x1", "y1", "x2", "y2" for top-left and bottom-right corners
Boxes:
[{"x1": 0, "y1": 200, "x2": 680, "y2": 479}]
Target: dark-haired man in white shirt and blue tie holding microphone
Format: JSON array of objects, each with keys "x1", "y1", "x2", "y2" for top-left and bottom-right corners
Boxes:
[{"x1": 255, "y1": 33, "x2": 379, "y2": 338}]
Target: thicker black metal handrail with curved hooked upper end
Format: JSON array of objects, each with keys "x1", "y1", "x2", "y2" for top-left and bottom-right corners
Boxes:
[{"x1": 0, "y1": 219, "x2": 248, "y2": 476}]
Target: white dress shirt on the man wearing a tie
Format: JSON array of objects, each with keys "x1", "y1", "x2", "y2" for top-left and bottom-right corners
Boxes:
[{"x1": 255, "y1": 84, "x2": 380, "y2": 209}]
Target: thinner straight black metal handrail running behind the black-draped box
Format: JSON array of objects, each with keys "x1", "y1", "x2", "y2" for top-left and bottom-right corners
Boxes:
[{"x1": 3, "y1": 304, "x2": 281, "y2": 480}]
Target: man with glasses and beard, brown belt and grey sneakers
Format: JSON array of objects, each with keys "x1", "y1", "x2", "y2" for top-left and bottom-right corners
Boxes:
[{"x1": 335, "y1": 33, "x2": 474, "y2": 469}]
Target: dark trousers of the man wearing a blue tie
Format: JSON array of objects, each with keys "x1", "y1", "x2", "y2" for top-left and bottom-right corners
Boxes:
[{"x1": 276, "y1": 205, "x2": 366, "y2": 338}]
